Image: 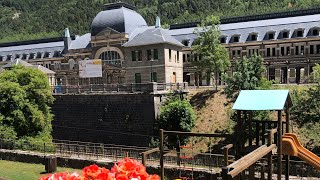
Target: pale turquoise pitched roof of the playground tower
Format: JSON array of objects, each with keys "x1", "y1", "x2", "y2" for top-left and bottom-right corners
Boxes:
[{"x1": 232, "y1": 90, "x2": 292, "y2": 111}]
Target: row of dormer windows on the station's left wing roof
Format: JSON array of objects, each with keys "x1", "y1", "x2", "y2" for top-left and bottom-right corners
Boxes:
[{"x1": 0, "y1": 51, "x2": 62, "y2": 61}]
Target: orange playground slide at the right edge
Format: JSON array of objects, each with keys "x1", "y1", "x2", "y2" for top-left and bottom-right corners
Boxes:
[{"x1": 282, "y1": 133, "x2": 320, "y2": 170}]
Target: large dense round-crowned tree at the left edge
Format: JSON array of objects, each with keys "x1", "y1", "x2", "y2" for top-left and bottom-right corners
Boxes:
[{"x1": 0, "y1": 66, "x2": 53, "y2": 138}]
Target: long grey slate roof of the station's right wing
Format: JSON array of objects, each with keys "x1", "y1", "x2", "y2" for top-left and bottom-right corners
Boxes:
[{"x1": 169, "y1": 14, "x2": 320, "y2": 46}]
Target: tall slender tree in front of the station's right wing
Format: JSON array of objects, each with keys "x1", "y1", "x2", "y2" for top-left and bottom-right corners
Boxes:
[{"x1": 194, "y1": 16, "x2": 230, "y2": 90}]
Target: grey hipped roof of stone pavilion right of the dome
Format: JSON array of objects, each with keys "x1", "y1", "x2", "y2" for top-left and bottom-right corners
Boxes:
[{"x1": 123, "y1": 28, "x2": 183, "y2": 47}]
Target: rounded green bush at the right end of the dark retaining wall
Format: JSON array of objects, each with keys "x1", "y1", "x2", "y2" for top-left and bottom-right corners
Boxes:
[{"x1": 157, "y1": 97, "x2": 196, "y2": 149}]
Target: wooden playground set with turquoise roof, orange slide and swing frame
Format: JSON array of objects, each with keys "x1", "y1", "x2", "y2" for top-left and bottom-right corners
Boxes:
[{"x1": 160, "y1": 90, "x2": 320, "y2": 180}]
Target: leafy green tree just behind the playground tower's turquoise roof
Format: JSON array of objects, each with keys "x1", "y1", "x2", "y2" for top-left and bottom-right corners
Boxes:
[{"x1": 223, "y1": 55, "x2": 271, "y2": 102}]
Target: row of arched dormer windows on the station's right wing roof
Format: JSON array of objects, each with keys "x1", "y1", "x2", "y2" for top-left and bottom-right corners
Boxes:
[{"x1": 220, "y1": 28, "x2": 319, "y2": 43}]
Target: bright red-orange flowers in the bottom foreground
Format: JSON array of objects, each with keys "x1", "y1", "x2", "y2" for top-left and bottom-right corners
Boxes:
[{"x1": 39, "y1": 158, "x2": 160, "y2": 180}]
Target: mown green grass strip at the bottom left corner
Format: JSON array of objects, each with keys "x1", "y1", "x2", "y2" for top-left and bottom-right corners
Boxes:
[{"x1": 0, "y1": 160, "x2": 81, "y2": 180}]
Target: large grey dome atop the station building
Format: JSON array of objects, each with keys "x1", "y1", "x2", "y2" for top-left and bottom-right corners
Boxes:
[{"x1": 91, "y1": 7, "x2": 147, "y2": 36}]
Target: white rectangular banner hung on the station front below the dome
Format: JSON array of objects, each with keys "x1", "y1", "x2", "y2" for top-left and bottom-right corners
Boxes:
[{"x1": 79, "y1": 59, "x2": 102, "y2": 78}]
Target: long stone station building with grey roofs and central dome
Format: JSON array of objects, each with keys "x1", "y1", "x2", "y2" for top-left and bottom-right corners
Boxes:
[{"x1": 0, "y1": 3, "x2": 320, "y2": 85}]
